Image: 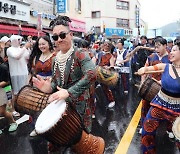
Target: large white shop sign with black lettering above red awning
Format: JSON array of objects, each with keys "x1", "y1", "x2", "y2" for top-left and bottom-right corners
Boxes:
[{"x1": 0, "y1": 0, "x2": 30, "y2": 21}]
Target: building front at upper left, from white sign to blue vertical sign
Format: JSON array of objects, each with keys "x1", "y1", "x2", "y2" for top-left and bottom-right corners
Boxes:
[{"x1": 0, "y1": 0, "x2": 55, "y2": 36}]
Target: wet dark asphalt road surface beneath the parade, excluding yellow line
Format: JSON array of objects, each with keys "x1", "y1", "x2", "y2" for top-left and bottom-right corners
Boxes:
[{"x1": 0, "y1": 83, "x2": 179, "y2": 154}]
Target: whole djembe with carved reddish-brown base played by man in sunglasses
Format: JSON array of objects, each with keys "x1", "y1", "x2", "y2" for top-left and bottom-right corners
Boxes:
[{"x1": 35, "y1": 100, "x2": 105, "y2": 154}]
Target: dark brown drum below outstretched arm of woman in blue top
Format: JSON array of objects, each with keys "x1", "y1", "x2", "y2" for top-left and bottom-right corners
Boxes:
[{"x1": 138, "y1": 77, "x2": 161, "y2": 102}]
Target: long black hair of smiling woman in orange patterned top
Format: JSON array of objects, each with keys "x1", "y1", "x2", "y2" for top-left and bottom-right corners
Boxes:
[{"x1": 28, "y1": 35, "x2": 53, "y2": 72}]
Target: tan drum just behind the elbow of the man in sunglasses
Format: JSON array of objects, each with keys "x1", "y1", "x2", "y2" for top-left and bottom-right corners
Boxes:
[{"x1": 96, "y1": 66, "x2": 119, "y2": 86}]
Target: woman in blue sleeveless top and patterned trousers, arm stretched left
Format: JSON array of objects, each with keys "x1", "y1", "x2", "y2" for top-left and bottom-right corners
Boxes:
[{"x1": 138, "y1": 42, "x2": 180, "y2": 154}]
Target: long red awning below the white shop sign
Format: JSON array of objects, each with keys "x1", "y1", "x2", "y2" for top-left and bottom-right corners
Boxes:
[{"x1": 0, "y1": 24, "x2": 45, "y2": 36}]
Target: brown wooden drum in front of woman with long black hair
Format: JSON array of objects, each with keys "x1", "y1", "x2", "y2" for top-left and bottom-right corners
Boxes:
[{"x1": 15, "y1": 85, "x2": 49, "y2": 114}]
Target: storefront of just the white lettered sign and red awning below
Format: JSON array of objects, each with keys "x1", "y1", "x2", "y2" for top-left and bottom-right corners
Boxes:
[{"x1": 0, "y1": 0, "x2": 45, "y2": 37}]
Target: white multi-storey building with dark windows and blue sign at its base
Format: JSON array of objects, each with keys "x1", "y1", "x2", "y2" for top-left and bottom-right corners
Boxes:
[{"x1": 85, "y1": 0, "x2": 144, "y2": 37}]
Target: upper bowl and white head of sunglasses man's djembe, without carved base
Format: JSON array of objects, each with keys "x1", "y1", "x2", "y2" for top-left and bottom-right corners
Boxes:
[{"x1": 35, "y1": 101, "x2": 82, "y2": 146}]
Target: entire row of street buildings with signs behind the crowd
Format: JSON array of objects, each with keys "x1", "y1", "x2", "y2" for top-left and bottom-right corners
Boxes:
[{"x1": 0, "y1": 0, "x2": 145, "y2": 38}]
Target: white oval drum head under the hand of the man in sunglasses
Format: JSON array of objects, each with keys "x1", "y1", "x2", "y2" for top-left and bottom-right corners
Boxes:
[{"x1": 35, "y1": 100, "x2": 66, "y2": 134}]
